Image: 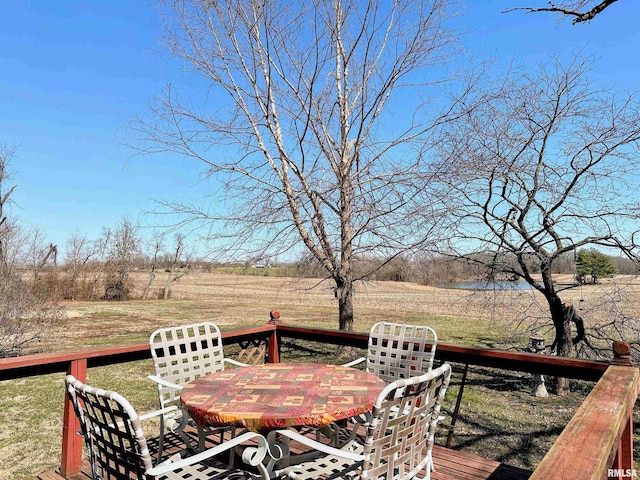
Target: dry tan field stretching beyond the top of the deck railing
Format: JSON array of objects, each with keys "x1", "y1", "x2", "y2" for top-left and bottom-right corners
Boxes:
[{"x1": 42, "y1": 273, "x2": 640, "y2": 351}]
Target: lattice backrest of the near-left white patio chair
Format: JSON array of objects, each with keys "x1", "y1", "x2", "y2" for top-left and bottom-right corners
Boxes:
[{"x1": 65, "y1": 375, "x2": 152, "y2": 480}]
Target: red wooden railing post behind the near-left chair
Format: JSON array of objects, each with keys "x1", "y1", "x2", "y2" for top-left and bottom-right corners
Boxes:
[{"x1": 60, "y1": 358, "x2": 87, "y2": 478}]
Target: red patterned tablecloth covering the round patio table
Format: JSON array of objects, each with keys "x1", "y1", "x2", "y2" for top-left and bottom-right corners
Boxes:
[{"x1": 180, "y1": 363, "x2": 386, "y2": 433}]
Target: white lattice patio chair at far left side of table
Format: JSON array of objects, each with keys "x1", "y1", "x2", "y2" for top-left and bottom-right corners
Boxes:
[{"x1": 148, "y1": 322, "x2": 247, "y2": 459}]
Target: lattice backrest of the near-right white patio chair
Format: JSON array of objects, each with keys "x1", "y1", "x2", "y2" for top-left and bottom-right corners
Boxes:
[{"x1": 361, "y1": 364, "x2": 451, "y2": 480}]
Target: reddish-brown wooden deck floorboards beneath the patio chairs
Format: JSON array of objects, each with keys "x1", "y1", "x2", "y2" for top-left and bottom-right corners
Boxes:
[{"x1": 37, "y1": 432, "x2": 531, "y2": 480}]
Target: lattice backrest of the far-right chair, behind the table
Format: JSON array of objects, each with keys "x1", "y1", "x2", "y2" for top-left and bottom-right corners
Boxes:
[{"x1": 367, "y1": 322, "x2": 438, "y2": 382}]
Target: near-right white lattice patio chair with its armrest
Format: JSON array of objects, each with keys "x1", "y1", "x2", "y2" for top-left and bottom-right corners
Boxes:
[{"x1": 276, "y1": 364, "x2": 451, "y2": 480}]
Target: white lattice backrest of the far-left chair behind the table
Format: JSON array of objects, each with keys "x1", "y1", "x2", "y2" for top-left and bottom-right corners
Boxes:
[{"x1": 149, "y1": 322, "x2": 224, "y2": 408}]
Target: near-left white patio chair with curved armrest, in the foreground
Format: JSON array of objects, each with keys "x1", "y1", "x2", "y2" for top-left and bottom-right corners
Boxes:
[{"x1": 65, "y1": 375, "x2": 269, "y2": 480}]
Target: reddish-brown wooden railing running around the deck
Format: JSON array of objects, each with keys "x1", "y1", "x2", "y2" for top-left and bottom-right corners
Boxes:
[{"x1": 0, "y1": 312, "x2": 640, "y2": 480}]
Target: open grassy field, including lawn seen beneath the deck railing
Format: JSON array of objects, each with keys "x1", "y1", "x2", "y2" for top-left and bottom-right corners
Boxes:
[{"x1": 0, "y1": 273, "x2": 640, "y2": 480}]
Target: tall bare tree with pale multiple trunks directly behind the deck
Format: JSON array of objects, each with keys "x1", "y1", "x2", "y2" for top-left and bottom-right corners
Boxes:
[{"x1": 134, "y1": 0, "x2": 472, "y2": 330}]
